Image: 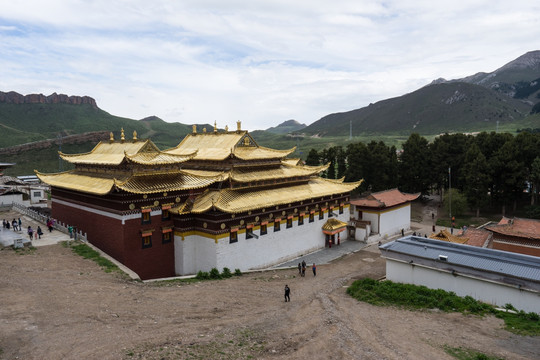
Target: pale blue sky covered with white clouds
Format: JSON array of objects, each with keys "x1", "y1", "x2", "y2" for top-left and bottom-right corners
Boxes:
[{"x1": 0, "y1": 0, "x2": 540, "y2": 130}]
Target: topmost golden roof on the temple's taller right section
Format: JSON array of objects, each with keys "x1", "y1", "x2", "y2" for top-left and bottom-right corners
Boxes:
[{"x1": 164, "y1": 131, "x2": 295, "y2": 161}]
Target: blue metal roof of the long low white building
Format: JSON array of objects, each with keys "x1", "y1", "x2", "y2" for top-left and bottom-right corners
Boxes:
[{"x1": 379, "y1": 236, "x2": 540, "y2": 281}]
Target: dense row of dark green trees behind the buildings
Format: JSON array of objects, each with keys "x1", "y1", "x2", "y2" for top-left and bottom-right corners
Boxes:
[{"x1": 306, "y1": 132, "x2": 540, "y2": 216}]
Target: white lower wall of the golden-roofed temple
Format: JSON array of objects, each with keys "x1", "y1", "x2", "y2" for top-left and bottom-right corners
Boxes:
[{"x1": 174, "y1": 207, "x2": 350, "y2": 275}]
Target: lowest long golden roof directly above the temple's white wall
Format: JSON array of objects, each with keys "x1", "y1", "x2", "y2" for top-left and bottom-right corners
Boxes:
[{"x1": 192, "y1": 178, "x2": 363, "y2": 213}]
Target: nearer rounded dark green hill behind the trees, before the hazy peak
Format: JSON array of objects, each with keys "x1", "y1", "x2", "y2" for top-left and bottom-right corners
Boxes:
[{"x1": 302, "y1": 82, "x2": 531, "y2": 136}]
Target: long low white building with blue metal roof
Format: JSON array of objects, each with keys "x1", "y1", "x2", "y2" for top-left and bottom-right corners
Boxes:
[{"x1": 379, "y1": 236, "x2": 540, "y2": 313}]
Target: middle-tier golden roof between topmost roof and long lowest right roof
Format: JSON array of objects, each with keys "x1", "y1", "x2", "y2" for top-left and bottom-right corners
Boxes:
[{"x1": 231, "y1": 163, "x2": 329, "y2": 182}]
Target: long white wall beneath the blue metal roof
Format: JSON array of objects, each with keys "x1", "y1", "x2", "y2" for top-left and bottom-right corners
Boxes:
[{"x1": 386, "y1": 258, "x2": 540, "y2": 312}]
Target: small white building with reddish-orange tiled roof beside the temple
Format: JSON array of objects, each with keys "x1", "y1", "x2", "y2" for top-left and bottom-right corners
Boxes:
[{"x1": 349, "y1": 189, "x2": 420, "y2": 242}]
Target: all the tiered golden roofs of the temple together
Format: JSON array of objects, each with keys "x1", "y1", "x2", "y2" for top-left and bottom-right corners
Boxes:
[{"x1": 36, "y1": 125, "x2": 361, "y2": 213}]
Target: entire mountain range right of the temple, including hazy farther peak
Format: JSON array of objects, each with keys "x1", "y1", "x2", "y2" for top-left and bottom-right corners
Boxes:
[{"x1": 303, "y1": 51, "x2": 540, "y2": 136}]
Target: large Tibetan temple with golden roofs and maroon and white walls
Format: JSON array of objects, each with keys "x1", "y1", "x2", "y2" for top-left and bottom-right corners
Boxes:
[{"x1": 36, "y1": 122, "x2": 360, "y2": 279}]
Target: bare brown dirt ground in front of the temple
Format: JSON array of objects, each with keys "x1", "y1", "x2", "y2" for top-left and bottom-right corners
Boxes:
[{"x1": 0, "y1": 245, "x2": 540, "y2": 360}]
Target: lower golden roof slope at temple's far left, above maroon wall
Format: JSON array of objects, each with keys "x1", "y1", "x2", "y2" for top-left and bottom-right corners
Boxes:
[{"x1": 35, "y1": 171, "x2": 126, "y2": 195}]
